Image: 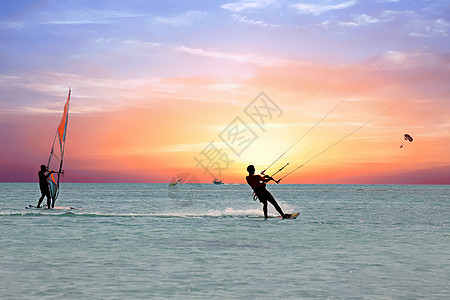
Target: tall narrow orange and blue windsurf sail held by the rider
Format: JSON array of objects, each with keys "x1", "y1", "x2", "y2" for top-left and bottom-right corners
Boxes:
[{"x1": 47, "y1": 88, "x2": 71, "y2": 205}]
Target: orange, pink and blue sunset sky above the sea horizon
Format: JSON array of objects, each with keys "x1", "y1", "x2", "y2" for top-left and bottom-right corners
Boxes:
[{"x1": 0, "y1": 0, "x2": 450, "y2": 184}]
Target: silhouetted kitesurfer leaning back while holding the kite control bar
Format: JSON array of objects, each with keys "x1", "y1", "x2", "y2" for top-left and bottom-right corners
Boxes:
[{"x1": 246, "y1": 165, "x2": 290, "y2": 218}]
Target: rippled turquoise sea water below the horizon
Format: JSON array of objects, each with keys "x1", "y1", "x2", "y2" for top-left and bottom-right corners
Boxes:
[{"x1": 0, "y1": 183, "x2": 450, "y2": 299}]
